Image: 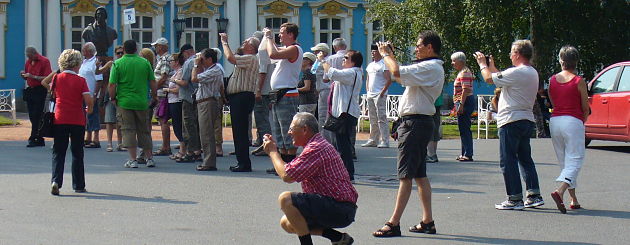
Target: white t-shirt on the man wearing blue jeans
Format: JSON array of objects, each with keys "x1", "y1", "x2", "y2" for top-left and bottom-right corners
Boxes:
[{"x1": 492, "y1": 65, "x2": 538, "y2": 127}]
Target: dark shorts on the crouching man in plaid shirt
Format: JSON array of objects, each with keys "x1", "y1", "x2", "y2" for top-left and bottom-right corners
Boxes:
[{"x1": 291, "y1": 192, "x2": 357, "y2": 230}]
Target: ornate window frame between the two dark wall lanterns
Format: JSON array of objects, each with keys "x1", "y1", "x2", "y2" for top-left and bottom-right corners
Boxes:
[{"x1": 175, "y1": 0, "x2": 223, "y2": 50}]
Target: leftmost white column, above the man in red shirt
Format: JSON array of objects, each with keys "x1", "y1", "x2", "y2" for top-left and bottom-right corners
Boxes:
[{"x1": 24, "y1": 0, "x2": 43, "y2": 52}]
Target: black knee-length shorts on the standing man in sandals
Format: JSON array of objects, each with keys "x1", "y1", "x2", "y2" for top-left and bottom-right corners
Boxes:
[{"x1": 398, "y1": 115, "x2": 435, "y2": 179}]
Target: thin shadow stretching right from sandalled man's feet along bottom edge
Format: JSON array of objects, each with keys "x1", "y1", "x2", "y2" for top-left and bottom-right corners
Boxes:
[{"x1": 407, "y1": 234, "x2": 596, "y2": 245}]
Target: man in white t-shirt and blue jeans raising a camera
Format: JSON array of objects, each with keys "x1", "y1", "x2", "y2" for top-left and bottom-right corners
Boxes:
[{"x1": 475, "y1": 40, "x2": 545, "y2": 210}]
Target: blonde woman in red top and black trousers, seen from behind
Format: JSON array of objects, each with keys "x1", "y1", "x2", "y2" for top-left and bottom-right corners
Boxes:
[{"x1": 42, "y1": 49, "x2": 94, "y2": 195}]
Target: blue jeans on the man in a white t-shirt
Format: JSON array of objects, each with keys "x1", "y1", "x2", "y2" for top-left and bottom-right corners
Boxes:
[{"x1": 499, "y1": 120, "x2": 540, "y2": 200}]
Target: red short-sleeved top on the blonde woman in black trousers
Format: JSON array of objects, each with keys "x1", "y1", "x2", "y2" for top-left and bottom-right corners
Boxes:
[{"x1": 50, "y1": 71, "x2": 90, "y2": 126}]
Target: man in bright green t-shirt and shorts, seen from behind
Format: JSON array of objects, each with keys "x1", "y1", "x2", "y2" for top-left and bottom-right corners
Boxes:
[{"x1": 109, "y1": 40, "x2": 157, "y2": 168}]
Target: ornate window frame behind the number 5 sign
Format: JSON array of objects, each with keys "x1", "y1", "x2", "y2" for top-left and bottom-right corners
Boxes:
[{"x1": 114, "y1": 0, "x2": 167, "y2": 46}]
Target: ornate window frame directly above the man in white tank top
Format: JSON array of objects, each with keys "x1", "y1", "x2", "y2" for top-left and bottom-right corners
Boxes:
[{"x1": 256, "y1": 0, "x2": 303, "y2": 31}]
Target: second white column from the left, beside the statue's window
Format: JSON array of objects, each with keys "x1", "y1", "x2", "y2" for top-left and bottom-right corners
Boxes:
[{"x1": 45, "y1": 0, "x2": 61, "y2": 71}]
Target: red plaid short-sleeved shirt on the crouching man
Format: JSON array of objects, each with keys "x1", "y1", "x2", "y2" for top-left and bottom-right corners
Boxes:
[{"x1": 284, "y1": 133, "x2": 359, "y2": 203}]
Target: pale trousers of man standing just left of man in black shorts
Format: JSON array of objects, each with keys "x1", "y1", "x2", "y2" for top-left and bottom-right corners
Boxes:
[{"x1": 366, "y1": 96, "x2": 389, "y2": 144}]
